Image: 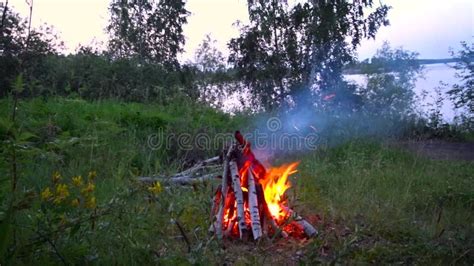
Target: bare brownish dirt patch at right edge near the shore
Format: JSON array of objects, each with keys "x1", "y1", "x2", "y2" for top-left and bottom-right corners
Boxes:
[{"x1": 397, "y1": 140, "x2": 474, "y2": 161}]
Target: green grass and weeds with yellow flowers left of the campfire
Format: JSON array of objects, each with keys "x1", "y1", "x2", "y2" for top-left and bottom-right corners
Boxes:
[{"x1": 0, "y1": 98, "x2": 243, "y2": 264}]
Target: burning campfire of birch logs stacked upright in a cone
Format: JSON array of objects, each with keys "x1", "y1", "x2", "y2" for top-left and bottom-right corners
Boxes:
[{"x1": 209, "y1": 131, "x2": 317, "y2": 240}]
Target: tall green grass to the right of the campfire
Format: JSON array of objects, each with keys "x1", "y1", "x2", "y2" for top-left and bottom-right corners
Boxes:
[{"x1": 296, "y1": 141, "x2": 474, "y2": 263}]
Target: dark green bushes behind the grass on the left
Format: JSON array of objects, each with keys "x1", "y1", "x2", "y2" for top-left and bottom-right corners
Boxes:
[{"x1": 1, "y1": 47, "x2": 198, "y2": 103}]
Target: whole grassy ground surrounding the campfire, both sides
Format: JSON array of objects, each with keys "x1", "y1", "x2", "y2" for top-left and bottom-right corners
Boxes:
[{"x1": 0, "y1": 99, "x2": 474, "y2": 265}]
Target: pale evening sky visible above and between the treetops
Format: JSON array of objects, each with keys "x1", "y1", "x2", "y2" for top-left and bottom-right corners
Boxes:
[{"x1": 7, "y1": 0, "x2": 474, "y2": 61}]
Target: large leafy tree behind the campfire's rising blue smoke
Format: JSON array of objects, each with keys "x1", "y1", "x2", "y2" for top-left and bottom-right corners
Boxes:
[{"x1": 229, "y1": 0, "x2": 389, "y2": 110}]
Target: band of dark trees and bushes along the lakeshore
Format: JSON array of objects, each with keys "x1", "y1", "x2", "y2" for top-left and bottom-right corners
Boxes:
[{"x1": 0, "y1": 0, "x2": 474, "y2": 125}]
